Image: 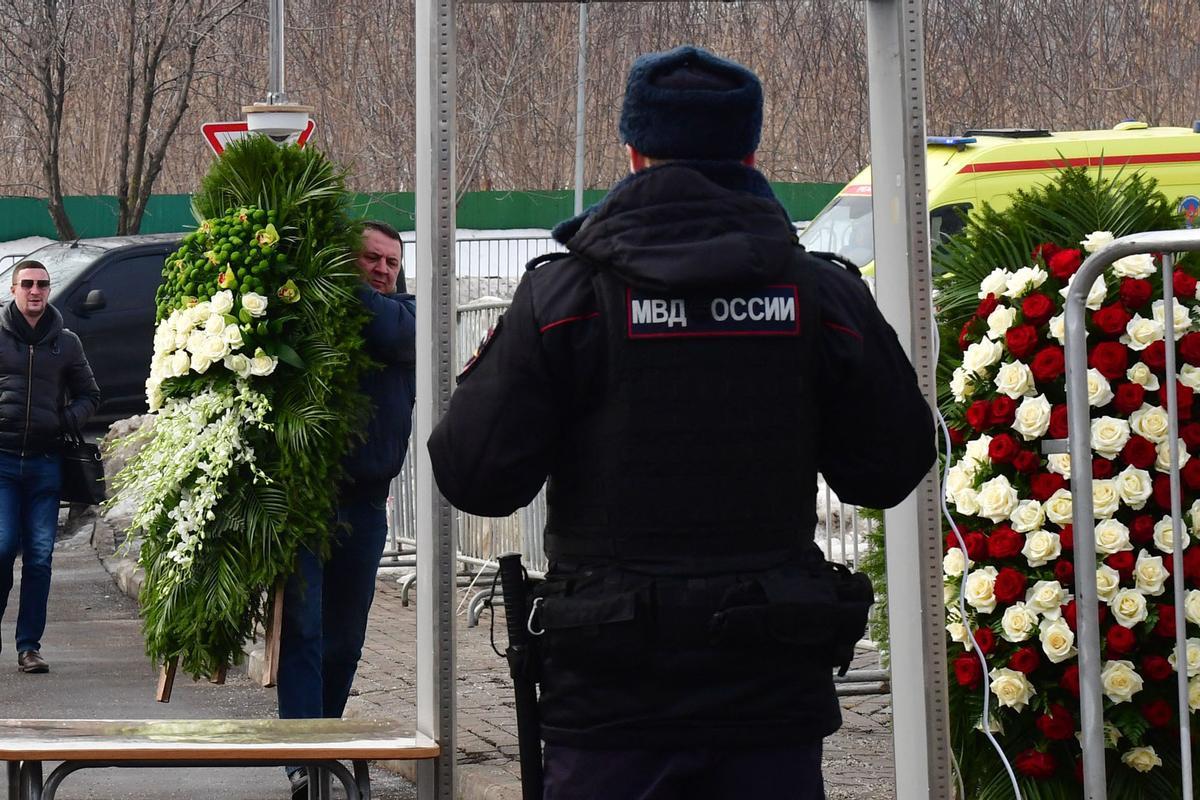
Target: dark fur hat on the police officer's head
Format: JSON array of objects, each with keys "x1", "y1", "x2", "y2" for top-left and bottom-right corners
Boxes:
[{"x1": 620, "y1": 46, "x2": 762, "y2": 161}]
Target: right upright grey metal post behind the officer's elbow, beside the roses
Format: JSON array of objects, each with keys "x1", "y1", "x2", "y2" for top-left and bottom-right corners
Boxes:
[{"x1": 866, "y1": 0, "x2": 952, "y2": 800}]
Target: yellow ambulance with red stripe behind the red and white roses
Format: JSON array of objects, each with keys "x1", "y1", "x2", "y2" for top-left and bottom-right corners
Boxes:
[{"x1": 800, "y1": 122, "x2": 1200, "y2": 275}]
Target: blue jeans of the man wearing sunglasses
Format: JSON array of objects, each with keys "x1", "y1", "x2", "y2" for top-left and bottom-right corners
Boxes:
[{"x1": 0, "y1": 452, "x2": 62, "y2": 652}]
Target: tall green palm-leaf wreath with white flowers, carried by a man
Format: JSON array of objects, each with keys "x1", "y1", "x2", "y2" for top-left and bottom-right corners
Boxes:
[{"x1": 112, "y1": 137, "x2": 370, "y2": 676}]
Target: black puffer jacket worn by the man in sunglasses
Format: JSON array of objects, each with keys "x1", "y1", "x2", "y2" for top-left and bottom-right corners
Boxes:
[{"x1": 0, "y1": 302, "x2": 100, "y2": 456}]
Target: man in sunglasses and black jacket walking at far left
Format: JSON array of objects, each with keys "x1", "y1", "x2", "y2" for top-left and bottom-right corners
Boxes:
[{"x1": 0, "y1": 260, "x2": 100, "y2": 673}]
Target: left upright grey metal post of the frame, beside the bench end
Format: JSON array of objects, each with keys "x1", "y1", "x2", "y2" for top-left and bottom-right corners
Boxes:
[{"x1": 413, "y1": 0, "x2": 458, "y2": 800}]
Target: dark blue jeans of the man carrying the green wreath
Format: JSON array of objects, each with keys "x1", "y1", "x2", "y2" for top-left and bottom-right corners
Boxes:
[{"x1": 277, "y1": 500, "x2": 388, "y2": 720}]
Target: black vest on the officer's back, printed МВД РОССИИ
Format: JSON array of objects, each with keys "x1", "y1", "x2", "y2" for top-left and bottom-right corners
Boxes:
[{"x1": 546, "y1": 251, "x2": 821, "y2": 572}]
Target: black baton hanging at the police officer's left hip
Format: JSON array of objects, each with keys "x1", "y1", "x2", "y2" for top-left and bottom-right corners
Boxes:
[{"x1": 498, "y1": 553, "x2": 542, "y2": 800}]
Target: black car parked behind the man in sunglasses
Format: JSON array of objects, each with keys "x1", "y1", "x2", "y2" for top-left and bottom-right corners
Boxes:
[{"x1": 0, "y1": 233, "x2": 184, "y2": 428}]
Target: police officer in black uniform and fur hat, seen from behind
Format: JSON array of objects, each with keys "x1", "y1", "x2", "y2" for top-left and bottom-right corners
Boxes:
[{"x1": 428, "y1": 47, "x2": 935, "y2": 800}]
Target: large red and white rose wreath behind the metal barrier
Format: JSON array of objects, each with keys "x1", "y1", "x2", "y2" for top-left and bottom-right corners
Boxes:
[{"x1": 935, "y1": 169, "x2": 1200, "y2": 799}]
